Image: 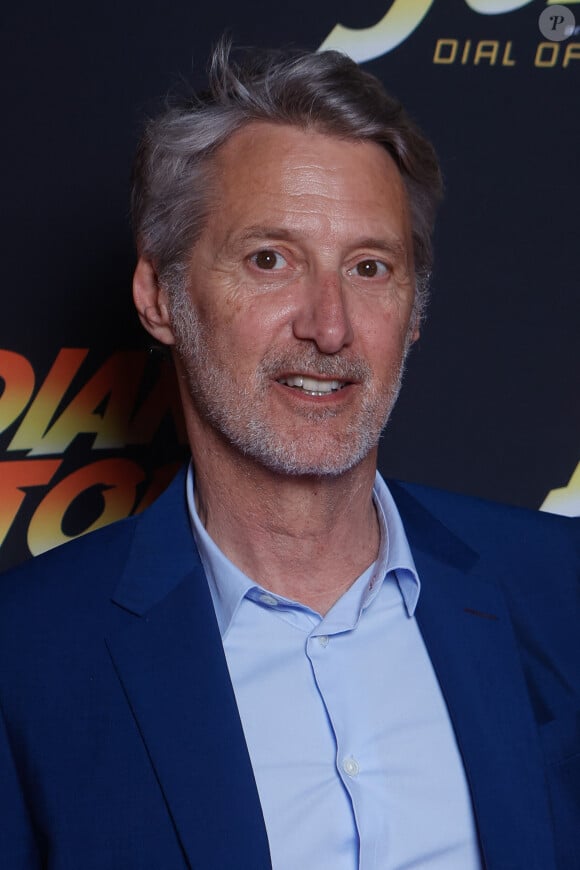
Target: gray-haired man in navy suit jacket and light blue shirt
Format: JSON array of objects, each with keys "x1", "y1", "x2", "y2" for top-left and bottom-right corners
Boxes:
[{"x1": 0, "y1": 39, "x2": 580, "y2": 870}]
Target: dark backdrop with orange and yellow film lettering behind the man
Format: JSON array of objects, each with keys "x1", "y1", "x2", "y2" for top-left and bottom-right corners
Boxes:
[{"x1": 0, "y1": 0, "x2": 580, "y2": 567}]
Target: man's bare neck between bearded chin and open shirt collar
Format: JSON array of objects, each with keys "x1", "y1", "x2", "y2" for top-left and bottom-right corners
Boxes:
[{"x1": 192, "y1": 439, "x2": 380, "y2": 613}]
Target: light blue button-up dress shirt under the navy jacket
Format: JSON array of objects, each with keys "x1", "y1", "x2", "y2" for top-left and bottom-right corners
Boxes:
[{"x1": 187, "y1": 469, "x2": 482, "y2": 870}]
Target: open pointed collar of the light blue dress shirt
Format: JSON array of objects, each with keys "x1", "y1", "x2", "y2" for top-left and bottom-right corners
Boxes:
[{"x1": 186, "y1": 463, "x2": 420, "y2": 639}]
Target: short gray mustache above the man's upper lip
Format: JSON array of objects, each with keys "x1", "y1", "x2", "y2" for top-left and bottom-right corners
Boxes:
[{"x1": 259, "y1": 347, "x2": 372, "y2": 382}]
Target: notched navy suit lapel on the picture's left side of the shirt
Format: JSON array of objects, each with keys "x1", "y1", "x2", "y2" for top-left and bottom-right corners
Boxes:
[{"x1": 107, "y1": 475, "x2": 270, "y2": 870}]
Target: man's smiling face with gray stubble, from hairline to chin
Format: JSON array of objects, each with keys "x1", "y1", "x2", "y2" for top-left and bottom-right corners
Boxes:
[{"x1": 172, "y1": 123, "x2": 416, "y2": 475}]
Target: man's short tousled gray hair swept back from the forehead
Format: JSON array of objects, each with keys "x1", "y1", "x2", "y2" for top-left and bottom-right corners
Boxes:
[{"x1": 131, "y1": 39, "x2": 442, "y2": 317}]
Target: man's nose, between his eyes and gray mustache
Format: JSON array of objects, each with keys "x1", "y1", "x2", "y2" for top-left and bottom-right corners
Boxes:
[{"x1": 293, "y1": 272, "x2": 354, "y2": 354}]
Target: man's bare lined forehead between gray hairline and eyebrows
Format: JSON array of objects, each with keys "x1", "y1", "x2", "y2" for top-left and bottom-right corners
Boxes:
[{"x1": 206, "y1": 122, "x2": 409, "y2": 244}]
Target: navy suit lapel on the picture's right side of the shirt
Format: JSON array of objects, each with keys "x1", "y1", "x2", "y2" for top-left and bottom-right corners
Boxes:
[{"x1": 391, "y1": 485, "x2": 555, "y2": 870}]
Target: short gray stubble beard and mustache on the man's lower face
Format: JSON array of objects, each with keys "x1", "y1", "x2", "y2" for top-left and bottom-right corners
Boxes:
[{"x1": 171, "y1": 291, "x2": 411, "y2": 477}]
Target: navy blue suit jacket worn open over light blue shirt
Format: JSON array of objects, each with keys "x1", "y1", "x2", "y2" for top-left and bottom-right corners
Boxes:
[{"x1": 0, "y1": 475, "x2": 580, "y2": 870}]
